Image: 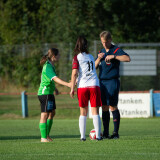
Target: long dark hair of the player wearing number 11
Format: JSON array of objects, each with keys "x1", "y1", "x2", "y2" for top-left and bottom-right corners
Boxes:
[{"x1": 74, "y1": 36, "x2": 88, "y2": 54}]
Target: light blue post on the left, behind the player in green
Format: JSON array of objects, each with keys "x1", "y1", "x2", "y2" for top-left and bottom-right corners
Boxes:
[{"x1": 21, "y1": 91, "x2": 28, "y2": 118}]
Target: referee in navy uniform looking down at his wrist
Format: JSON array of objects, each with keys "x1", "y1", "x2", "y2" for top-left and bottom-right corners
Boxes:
[{"x1": 95, "y1": 31, "x2": 131, "y2": 139}]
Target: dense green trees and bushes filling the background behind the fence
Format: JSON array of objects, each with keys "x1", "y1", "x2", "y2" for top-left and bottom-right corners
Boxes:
[{"x1": 0, "y1": 0, "x2": 160, "y2": 90}]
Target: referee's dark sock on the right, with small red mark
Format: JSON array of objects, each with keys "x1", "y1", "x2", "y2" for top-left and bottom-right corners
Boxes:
[{"x1": 112, "y1": 109, "x2": 120, "y2": 134}]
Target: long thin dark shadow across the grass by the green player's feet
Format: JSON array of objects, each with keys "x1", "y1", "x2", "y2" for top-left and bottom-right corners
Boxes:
[{"x1": 0, "y1": 135, "x2": 80, "y2": 140}]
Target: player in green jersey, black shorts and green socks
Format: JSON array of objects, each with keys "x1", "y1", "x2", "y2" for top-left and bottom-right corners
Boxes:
[{"x1": 38, "y1": 48, "x2": 71, "y2": 142}]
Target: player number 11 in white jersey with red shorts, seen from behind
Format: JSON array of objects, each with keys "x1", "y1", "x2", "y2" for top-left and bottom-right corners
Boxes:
[{"x1": 70, "y1": 36, "x2": 102, "y2": 141}]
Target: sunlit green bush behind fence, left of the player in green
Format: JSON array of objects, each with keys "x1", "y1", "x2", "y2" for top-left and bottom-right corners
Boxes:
[{"x1": 0, "y1": 46, "x2": 42, "y2": 88}]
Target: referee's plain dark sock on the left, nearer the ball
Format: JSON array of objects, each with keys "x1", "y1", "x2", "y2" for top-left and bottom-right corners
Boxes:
[{"x1": 102, "y1": 111, "x2": 110, "y2": 135}]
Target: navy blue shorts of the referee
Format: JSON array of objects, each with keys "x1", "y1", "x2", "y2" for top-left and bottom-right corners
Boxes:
[{"x1": 100, "y1": 79, "x2": 120, "y2": 106}]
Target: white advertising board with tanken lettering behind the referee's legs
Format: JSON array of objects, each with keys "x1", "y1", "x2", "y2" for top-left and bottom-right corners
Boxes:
[{"x1": 88, "y1": 93, "x2": 151, "y2": 118}]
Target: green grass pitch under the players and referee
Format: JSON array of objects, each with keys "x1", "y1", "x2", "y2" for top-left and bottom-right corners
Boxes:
[{"x1": 0, "y1": 118, "x2": 160, "y2": 160}]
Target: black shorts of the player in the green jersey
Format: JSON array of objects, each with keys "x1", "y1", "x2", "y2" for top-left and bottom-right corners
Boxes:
[{"x1": 38, "y1": 94, "x2": 56, "y2": 112}]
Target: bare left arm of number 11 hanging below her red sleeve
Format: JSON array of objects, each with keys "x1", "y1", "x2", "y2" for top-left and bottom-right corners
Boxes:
[{"x1": 70, "y1": 69, "x2": 78, "y2": 98}]
